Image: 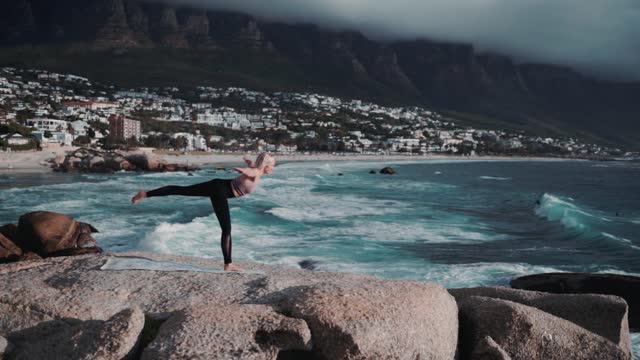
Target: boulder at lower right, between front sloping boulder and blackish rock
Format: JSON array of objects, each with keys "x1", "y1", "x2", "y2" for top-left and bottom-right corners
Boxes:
[{"x1": 448, "y1": 287, "x2": 631, "y2": 354}]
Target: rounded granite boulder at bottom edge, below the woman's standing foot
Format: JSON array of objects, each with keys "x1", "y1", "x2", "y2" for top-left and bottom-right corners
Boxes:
[{"x1": 142, "y1": 304, "x2": 311, "y2": 360}]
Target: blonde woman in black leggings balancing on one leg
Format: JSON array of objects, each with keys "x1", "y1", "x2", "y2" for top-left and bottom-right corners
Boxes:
[{"x1": 131, "y1": 153, "x2": 276, "y2": 271}]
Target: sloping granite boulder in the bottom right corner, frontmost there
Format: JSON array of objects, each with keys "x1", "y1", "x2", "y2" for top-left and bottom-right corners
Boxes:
[{"x1": 458, "y1": 296, "x2": 630, "y2": 360}]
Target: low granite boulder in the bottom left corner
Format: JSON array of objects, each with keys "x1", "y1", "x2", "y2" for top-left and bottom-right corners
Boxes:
[{"x1": 8, "y1": 308, "x2": 144, "y2": 360}]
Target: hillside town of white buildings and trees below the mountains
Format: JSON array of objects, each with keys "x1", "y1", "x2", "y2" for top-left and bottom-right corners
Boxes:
[{"x1": 0, "y1": 67, "x2": 637, "y2": 158}]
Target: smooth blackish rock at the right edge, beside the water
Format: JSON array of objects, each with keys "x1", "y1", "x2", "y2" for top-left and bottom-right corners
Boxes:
[{"x1": 511, "y1": 273, "x2": 640, "y2": 329}]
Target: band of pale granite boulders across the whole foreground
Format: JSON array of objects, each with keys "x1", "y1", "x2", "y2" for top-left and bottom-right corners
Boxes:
[{"x1": 0, "y1": 252, "x2": 632, "y2": 359}]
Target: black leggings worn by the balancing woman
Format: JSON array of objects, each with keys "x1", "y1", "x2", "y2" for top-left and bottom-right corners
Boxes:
[{"x1": 147, "y1": 179, "x2": 234, "y2": 264}]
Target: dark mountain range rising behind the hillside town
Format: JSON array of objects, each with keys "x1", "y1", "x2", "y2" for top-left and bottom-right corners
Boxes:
[{"x1": 0, "y1": 0, "x2": 640, "y2": 149}]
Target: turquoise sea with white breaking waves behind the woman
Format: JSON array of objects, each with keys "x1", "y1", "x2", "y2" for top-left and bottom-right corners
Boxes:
[{"x1": 0, "y1": 161, "x2": 640, "y2": 354}]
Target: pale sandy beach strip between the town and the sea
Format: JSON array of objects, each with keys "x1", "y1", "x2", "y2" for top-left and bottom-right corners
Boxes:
[{"x1": 0, "y1": 147, "x2": 587, "y2": 174}]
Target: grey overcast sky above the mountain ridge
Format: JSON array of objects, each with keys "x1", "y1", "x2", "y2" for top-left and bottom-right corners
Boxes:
[{"x1": 152, "y1": 0, "x2": 640, "y2": 80}]
